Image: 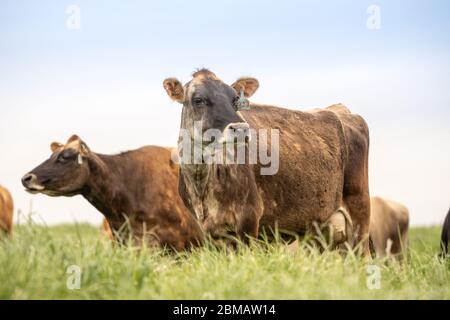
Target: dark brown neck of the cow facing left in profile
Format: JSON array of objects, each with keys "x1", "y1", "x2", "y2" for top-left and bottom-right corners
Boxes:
[{"x1": 82, "y1": 154, "x2": 131, "y2": 223}]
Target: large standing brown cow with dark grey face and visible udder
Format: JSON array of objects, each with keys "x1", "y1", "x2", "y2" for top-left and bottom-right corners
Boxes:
[{"x1": 164, "y1": 69, "x2": 370, "y2": 254}]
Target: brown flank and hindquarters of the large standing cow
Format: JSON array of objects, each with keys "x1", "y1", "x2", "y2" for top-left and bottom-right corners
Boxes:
[{"x1": 242, "y1": 105, "x2": 370, "y2": 251}]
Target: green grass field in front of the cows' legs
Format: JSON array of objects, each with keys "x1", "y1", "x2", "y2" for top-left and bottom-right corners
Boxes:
[{"x1": 0, "y1": 220, "x2": 450, "y2": 299}]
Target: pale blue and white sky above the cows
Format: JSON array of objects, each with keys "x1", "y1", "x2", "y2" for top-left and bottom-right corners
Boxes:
[{"x1": 0, "y1": 0, "x2": 450, "y2": 224}]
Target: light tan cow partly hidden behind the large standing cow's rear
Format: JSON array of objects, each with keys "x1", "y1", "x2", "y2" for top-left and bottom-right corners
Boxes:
[{"x1": 370, "y1": 197, "x2": 409, "y2": 257}]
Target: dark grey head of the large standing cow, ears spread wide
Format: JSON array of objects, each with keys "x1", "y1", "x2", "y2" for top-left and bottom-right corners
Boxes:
[{"x1": 164, "y1": 69, "x2": 259, "y2": 144}]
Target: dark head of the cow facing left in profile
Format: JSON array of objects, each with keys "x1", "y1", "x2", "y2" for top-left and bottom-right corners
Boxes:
[{"x1": 22, "y1": 135, "x2": 91, "y2": 197}]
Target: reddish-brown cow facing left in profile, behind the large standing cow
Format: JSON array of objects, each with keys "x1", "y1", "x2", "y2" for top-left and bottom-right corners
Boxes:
[{"x1": 22, "y1": 136, "x2": 202, "y2": 250}]
